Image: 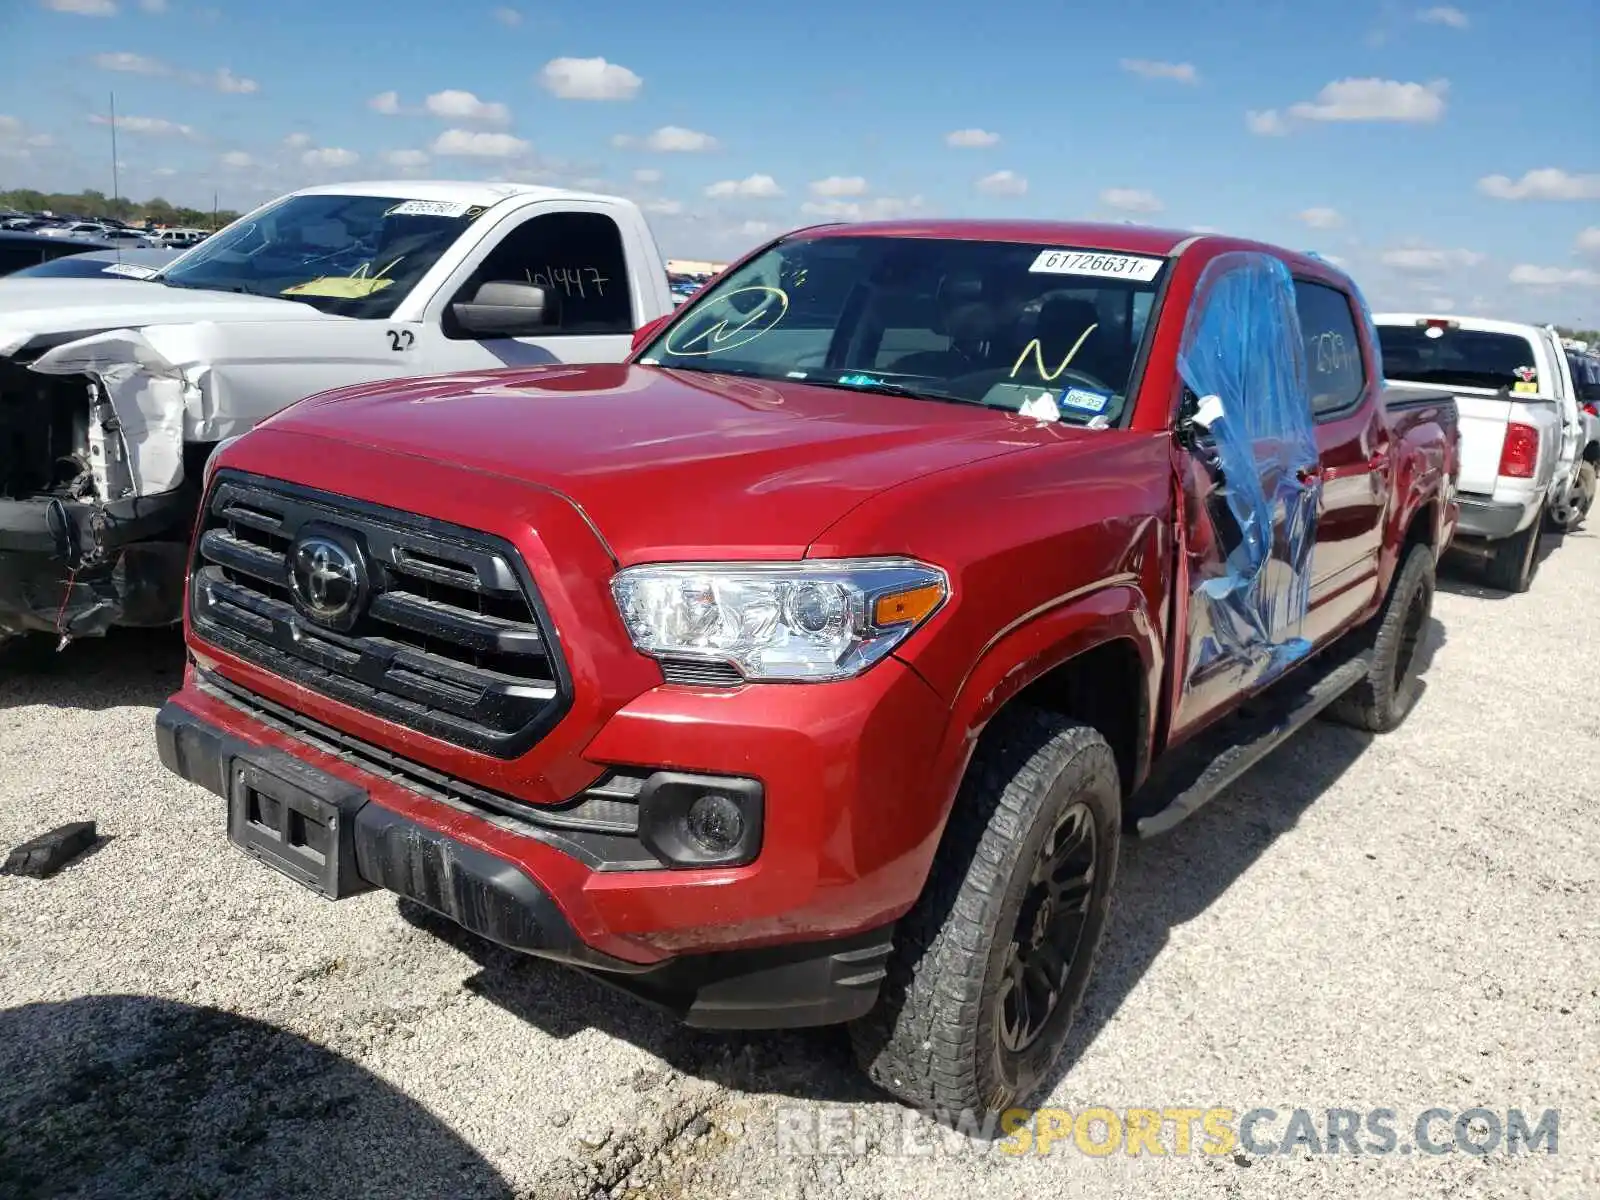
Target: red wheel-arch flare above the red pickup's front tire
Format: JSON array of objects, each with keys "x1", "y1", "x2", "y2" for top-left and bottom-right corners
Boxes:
[{"x1": 930, "y1": 573, "x2": 1162, "y2": 857}]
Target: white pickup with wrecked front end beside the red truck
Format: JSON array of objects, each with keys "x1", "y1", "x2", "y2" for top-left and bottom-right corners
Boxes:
[{"x1": 0, "y1": 181, "x2": 672, "y2": 640}]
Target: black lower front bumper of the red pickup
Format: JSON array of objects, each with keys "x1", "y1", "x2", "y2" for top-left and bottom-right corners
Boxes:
[{"x1": 155, "y1": 701, "x2": 894, "y2": 1029}]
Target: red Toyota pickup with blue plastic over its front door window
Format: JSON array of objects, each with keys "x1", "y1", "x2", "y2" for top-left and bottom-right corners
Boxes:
[{"x1": 157, "y1": 221, "x2": 1458, "y2": 1110}]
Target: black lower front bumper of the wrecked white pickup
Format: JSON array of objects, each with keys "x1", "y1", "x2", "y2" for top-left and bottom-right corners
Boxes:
[{"x1": 0, "y1": 486, "x2": 195, "y2": 637}]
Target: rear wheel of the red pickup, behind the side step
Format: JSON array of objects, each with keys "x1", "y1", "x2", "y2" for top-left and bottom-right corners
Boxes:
[{"x1": 1326, "y1": 546, "x2": 1434, "y2": 733}]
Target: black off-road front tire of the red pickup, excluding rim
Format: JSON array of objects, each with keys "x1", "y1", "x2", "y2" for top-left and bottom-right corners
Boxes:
[{"x1": 851, "y1": 706, "x2": 1122, "y2": 1114}]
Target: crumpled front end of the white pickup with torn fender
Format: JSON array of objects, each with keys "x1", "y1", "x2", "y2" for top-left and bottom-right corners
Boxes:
[{"x1": 0, "y1": 330, "x2": 203, "y2": 638}]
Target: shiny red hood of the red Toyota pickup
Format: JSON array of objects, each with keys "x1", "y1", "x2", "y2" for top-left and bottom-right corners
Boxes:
[{"x1": 261, "y1": 365, "x2": 1062, "y2": 565}]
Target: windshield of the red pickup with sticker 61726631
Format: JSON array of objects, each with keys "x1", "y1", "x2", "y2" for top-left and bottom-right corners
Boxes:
[{"x1": 640, "y1": 235, "x2": 1165, "y2": 424}]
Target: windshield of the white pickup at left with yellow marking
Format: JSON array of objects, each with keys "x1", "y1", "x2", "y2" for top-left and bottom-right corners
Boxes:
[{"x1": 162, "y1": 195, "x2": 483, "y2": 320}]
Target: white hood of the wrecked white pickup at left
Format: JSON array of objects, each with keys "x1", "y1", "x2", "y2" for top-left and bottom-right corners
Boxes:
[{"x1": 0, "y1": 277, "x2": 334, "y2": 354}]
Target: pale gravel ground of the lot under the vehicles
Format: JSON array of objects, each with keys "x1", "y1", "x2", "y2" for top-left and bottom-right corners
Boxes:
[{"x1": 0, "y1": 534, "x2": 1600, "y2": 1200}]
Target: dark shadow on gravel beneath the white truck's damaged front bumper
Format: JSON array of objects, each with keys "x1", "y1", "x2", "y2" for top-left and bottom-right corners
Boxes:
[{"x1": 0, "y1": 627, "x2": 184, "y2": 710}]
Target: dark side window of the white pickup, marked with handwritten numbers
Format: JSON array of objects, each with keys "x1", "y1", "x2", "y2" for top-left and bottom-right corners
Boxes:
[{"x1": 470, "y1": 213, "x2": 634, "y2": 334}]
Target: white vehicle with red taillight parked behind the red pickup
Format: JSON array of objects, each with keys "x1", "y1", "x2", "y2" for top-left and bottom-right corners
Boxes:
[{"x1": 1373, "y1": 312, "x2": 1594, "y2": 592}]
